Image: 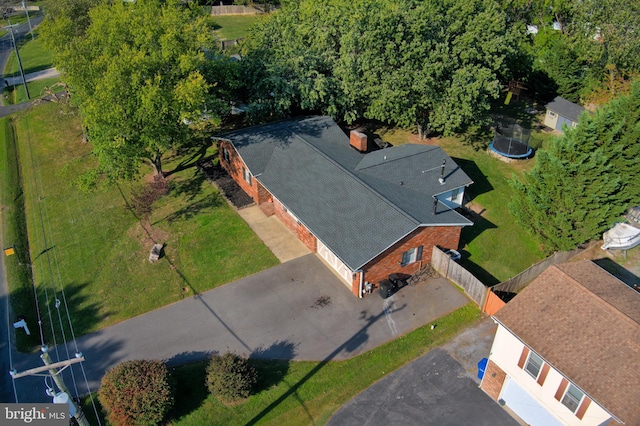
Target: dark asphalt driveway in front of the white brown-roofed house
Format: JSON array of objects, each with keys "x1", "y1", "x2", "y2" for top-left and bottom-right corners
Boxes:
[{"x1": 327, "y1": 318, "x2": 518, "y2": 426}]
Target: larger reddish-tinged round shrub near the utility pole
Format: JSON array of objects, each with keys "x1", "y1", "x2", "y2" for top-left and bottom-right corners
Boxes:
[{"x1": 98, "y1": 360, "x2": 174, "y2": 425}]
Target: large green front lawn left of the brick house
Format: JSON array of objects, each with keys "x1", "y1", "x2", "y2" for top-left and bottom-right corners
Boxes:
[{"x1": 6, "y1": 104, "x2": 277, "y2": 350}]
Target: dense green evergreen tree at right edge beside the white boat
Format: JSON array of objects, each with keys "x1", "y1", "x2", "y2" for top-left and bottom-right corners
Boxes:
[{"x1": 510, "y1": 83, "x2": 640, "y2": 251}]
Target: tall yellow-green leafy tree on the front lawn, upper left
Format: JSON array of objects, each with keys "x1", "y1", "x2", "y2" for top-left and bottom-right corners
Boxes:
[{"x1": 45, "y1": 0, "x2": 216, "y2": 179}]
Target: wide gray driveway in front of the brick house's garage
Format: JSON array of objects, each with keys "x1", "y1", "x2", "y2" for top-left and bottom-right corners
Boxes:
[{"x1": 14, "y1": 254, "x2": 468, "y2": 402}]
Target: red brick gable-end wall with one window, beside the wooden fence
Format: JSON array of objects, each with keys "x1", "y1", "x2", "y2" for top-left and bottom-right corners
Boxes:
[{"x1": 362, "y1": 226, "x2": 462, "y2": 284}]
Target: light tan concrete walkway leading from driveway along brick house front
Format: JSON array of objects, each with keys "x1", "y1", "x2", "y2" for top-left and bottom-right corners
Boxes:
[{"x1": 238, "y1": 206, "x2": 311, "y2": 263}]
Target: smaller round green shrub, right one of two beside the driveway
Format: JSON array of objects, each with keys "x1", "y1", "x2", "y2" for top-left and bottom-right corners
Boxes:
[{"x1": 206, "y1": 352, "x2": 257, "y2": 402}]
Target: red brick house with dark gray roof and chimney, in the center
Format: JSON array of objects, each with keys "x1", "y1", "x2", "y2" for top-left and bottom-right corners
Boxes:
[{"x1": 218, "y1": 117, "x2": 472, "y2": 296}]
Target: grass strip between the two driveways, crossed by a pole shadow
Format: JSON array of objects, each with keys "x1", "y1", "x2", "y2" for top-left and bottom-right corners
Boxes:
[{"x1": 77, "y1": 304, "x2": 480, "y2": 426}]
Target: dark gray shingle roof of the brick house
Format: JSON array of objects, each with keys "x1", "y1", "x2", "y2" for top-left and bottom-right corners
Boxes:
[{"x1": 221, "y1": 117, "x2": 472, "y2": 271}]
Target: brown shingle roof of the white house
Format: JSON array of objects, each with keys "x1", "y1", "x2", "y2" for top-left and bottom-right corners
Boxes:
[{"x1": 494, "y1": 260, "x2": 640, "y2": 425}]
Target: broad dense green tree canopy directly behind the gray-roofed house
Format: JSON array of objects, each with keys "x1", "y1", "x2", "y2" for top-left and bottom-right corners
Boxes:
[{"x1": 245, "y1": 0, "x2": 516, "y2": 133}]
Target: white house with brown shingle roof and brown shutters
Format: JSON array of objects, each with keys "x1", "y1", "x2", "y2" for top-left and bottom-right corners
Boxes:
[{"x1": 481, "y1": 261, "x2": 640, "y2": 426}]
